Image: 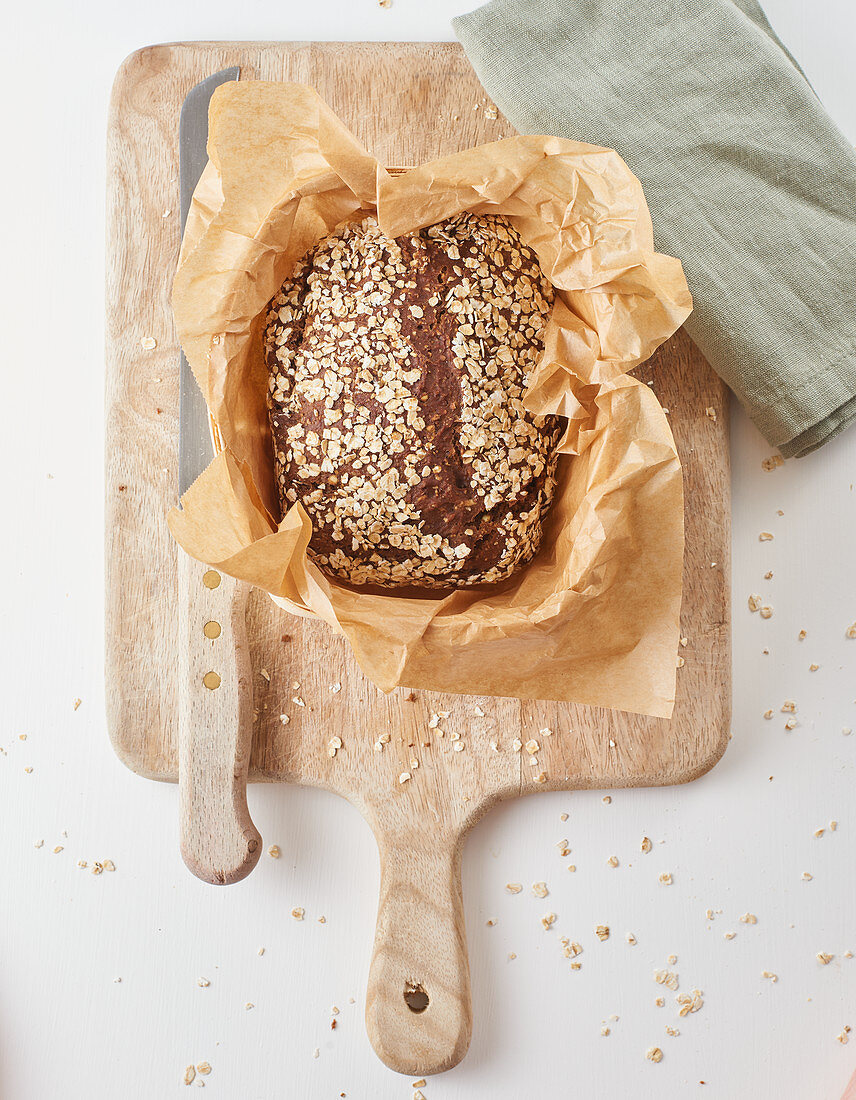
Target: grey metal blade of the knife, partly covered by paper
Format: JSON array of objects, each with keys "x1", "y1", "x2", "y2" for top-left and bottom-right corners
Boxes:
[{"x1": 178, "y1": 66, "x2": 241, "y2": 496}]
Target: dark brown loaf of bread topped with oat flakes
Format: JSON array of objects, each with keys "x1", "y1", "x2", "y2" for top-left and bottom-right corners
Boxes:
[{"x1": 264, "y1": 215, "x2": 561, "y2": 589}]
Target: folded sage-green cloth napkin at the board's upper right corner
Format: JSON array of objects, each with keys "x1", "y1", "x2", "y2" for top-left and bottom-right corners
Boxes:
[{"x1": 453, "y1": 0, "x2": 856, "y2": 458}]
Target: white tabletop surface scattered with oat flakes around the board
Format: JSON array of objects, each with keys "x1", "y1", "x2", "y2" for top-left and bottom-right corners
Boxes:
[{"x1": 0, "y1": 0, "x2": 856, "y2": 1100}]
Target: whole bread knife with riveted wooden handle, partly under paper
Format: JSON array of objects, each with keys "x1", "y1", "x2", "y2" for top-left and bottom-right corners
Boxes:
[{"x1": 173, "y1": 68, "x2": 262, "y2": 886}]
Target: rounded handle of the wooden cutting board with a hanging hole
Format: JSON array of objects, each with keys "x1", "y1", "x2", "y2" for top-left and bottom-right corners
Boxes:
[{"x1": 365, "y1": 826, "x2": 472, "y2": 1077}]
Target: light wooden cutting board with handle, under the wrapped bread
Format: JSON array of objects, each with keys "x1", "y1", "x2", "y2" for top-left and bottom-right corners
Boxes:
[{"x1": 101, "y1": 43, "x2": 731, "y2": 1075}]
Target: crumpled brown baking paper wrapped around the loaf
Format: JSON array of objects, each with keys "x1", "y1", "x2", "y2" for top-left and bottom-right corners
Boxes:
[{"x1": 169, "y1": 81, "x2": 692, "y2": 717}]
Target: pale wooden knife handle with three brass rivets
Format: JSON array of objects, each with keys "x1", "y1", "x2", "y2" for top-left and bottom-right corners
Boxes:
[{"x1": 178, "y1": 552, "x2": 262, "y2": 886}]
